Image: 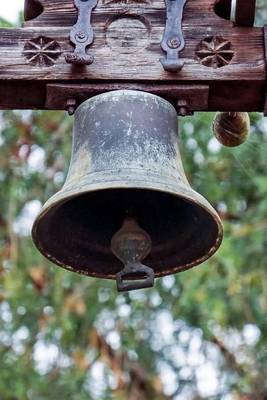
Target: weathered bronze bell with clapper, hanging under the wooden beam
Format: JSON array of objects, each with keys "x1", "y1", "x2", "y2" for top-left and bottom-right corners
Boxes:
[{"x1": 32, "y1": 90, "x2": 222, "y2": 291}]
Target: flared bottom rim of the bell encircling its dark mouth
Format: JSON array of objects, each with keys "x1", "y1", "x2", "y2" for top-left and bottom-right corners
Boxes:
[{"x1": 32, "y1": 178, "x2": 223, "y2": 280}]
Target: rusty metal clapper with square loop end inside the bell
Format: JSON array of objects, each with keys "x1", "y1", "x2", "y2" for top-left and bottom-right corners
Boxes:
[{"x1": 111, "y1": 216, "x2": 155, "y2": 292}]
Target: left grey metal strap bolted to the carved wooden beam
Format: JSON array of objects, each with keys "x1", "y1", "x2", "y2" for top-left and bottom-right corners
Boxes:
[{"x1": 65, "y1": 0, "x2": 98, "y2": 65}]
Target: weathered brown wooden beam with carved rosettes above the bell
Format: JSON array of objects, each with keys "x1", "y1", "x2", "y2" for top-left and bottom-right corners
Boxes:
[{"x1": 0, "y1": 0, "x2": 266, "y2": 111}]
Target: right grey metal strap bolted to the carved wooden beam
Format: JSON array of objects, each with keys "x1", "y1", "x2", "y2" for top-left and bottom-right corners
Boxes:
[{"x1": 160, "y1": 0, "x2": 187, "y2": 72}]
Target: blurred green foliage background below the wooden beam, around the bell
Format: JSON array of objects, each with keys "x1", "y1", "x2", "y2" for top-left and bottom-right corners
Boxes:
[{"x1": 0, "y1": 5, "x2": 267, "y2": 400}]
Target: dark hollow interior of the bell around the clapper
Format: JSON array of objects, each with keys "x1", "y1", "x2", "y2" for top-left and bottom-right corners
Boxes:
[{"x1": 32, "y1": 188, "x2": 222, "y2": 279}]
